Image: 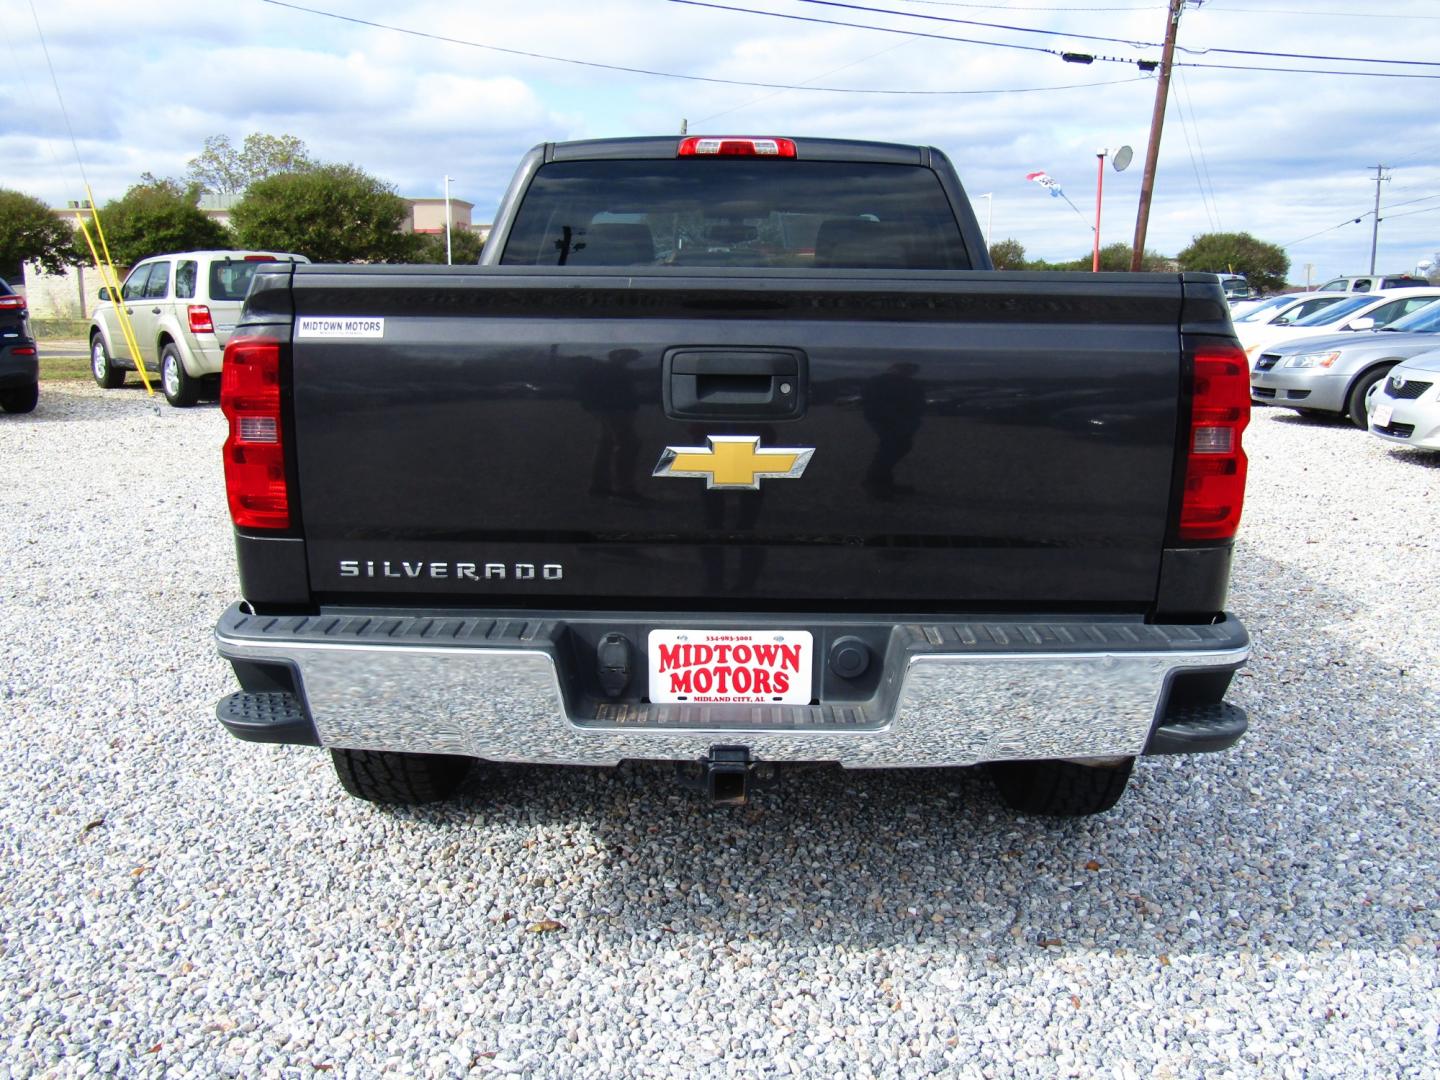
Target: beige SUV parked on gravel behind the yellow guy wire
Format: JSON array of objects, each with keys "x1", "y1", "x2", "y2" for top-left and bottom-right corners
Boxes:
[{"x1": 89, "y1": 251, "x2": 310, "y2": 406}]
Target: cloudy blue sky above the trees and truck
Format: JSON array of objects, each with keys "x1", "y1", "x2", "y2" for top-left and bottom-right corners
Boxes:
[{"x1": 0, "y1": 0, "x2": 1440, "y2": 284}]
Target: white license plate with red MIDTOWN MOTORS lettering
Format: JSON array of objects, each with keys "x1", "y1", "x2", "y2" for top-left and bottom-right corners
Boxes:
[{"x1": 649, "y1": 629, "x2": 815, "y2": 706}]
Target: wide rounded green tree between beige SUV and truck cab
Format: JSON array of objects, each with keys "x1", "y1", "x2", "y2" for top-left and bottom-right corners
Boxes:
[{"x1": 232, "y1": 166, "x2": 419, "y2": 262}]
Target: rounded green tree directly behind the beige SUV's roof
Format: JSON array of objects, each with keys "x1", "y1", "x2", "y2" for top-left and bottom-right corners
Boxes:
[{"x1": 87, "y1": 173, "x2": 230, "y2": 266}]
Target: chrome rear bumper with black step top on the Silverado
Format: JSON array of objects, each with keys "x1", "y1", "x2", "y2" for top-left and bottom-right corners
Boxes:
[{"x1": 216, "y1": 605, "x2": 1250, "y2": 769}]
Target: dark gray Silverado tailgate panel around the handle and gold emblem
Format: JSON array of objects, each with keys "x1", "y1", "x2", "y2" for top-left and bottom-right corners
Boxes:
[{"x1": 292, "y1": 266, "x2": 1182, "y2": 611}]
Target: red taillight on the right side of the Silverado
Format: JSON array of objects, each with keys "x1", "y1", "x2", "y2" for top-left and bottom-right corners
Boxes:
[{"x1": 1179, "y1": 344, "x2": 1250, "y2": 540}]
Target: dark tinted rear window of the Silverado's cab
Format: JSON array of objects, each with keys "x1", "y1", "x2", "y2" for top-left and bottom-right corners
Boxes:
[{"x1": 501, "y1": 158, "x2": 971, "y2": 269}]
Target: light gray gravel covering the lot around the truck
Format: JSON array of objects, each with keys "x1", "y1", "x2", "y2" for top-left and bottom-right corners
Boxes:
[{"x1": 0, "y1": 383, "x2": 1440, "y2": 1077}]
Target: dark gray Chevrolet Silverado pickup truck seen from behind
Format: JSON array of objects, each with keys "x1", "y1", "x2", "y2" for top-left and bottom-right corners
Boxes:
[{"x1": 216, "y1": 137, "x2": 1250, "y2": 815}]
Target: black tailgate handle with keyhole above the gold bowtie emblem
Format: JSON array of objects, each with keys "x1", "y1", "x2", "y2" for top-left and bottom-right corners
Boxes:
[{"x1": 664, "y1": 348, "x2": 808, "y2": 420}]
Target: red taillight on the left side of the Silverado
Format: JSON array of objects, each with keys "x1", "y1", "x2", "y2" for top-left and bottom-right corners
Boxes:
[{"x1": 220, "y1": 337, "x2": 289, "y2": 528}]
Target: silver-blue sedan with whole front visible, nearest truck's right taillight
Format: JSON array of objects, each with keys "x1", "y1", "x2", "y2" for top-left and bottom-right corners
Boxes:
[{"x1": 1250, "y1": 304, "x2": 1440, "y2": 428}]
